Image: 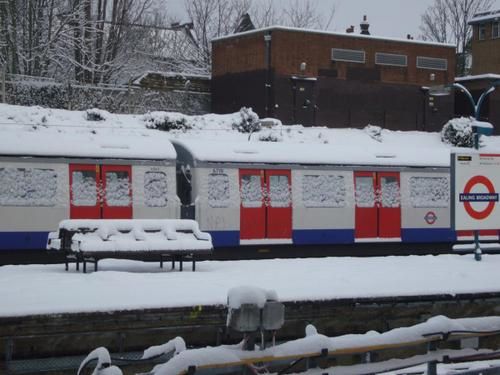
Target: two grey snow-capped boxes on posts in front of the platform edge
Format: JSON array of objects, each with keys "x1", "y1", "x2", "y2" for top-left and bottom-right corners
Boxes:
[{"x1": 226, "y1": 286, "x2": 285, "y2": 350}]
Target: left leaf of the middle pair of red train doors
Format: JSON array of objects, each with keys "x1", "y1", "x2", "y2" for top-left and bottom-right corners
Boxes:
[{"x1": 240, "y1": 169, "x2": 266, "y2": 240}]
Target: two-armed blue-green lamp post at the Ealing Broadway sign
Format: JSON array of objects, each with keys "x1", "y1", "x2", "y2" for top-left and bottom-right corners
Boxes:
[{"x1": 429, "y1": 80, "x2": 500, "y2": 261}]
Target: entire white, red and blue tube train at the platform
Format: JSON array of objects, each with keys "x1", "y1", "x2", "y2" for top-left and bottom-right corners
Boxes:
[{"x1": 0, "y1": 128, "x2": 492, "y2": 258}]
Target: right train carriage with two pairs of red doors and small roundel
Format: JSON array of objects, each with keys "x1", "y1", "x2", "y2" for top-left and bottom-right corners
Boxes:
[{"x1": 173, "y1": 140, "x2": 457, "y2": 249}]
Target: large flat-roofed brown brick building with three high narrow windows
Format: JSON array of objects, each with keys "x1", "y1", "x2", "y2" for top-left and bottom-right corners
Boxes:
[{"x1": 212, "y1": 22, "x2": 455, "y2": 131}]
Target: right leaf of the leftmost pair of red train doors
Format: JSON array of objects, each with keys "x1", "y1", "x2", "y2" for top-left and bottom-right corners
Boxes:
[{"x1": 101, "y1": 165, "x2": 132, "y2": 219}]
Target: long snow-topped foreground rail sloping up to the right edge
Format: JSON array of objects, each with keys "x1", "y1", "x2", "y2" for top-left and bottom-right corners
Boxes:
[{"x1": 149, "y1": 316, "x2": 500, "y2": 375}]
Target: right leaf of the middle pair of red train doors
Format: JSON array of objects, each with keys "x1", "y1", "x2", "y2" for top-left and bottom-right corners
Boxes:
[{"x1": 266, "y1": 170, "x2": 292, "y2": 239}]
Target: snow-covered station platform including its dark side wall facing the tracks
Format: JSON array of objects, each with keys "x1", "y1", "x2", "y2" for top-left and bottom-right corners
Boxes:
[{"x1": 0, "y1": 255, "x2": 500, "y2": 364}]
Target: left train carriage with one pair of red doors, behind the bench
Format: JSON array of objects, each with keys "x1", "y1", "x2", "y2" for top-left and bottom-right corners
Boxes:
[{"x1": 0, "y1": 128, "x2": 180, "y2": 250}]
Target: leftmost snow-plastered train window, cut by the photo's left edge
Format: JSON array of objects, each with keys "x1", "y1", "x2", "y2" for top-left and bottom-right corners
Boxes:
[{"x1": 0, "y1": 168, "x2": 57, "y2": 206}]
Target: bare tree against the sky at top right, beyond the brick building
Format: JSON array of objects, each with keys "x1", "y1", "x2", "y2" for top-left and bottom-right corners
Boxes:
[{"x1": 420, "y1": 0, "x2": 494, "y2": 75}]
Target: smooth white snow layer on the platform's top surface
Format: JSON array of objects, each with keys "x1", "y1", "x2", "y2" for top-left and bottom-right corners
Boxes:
[{"x1": 0, "y1": 255, "x2": 500, "y2": 316}]
